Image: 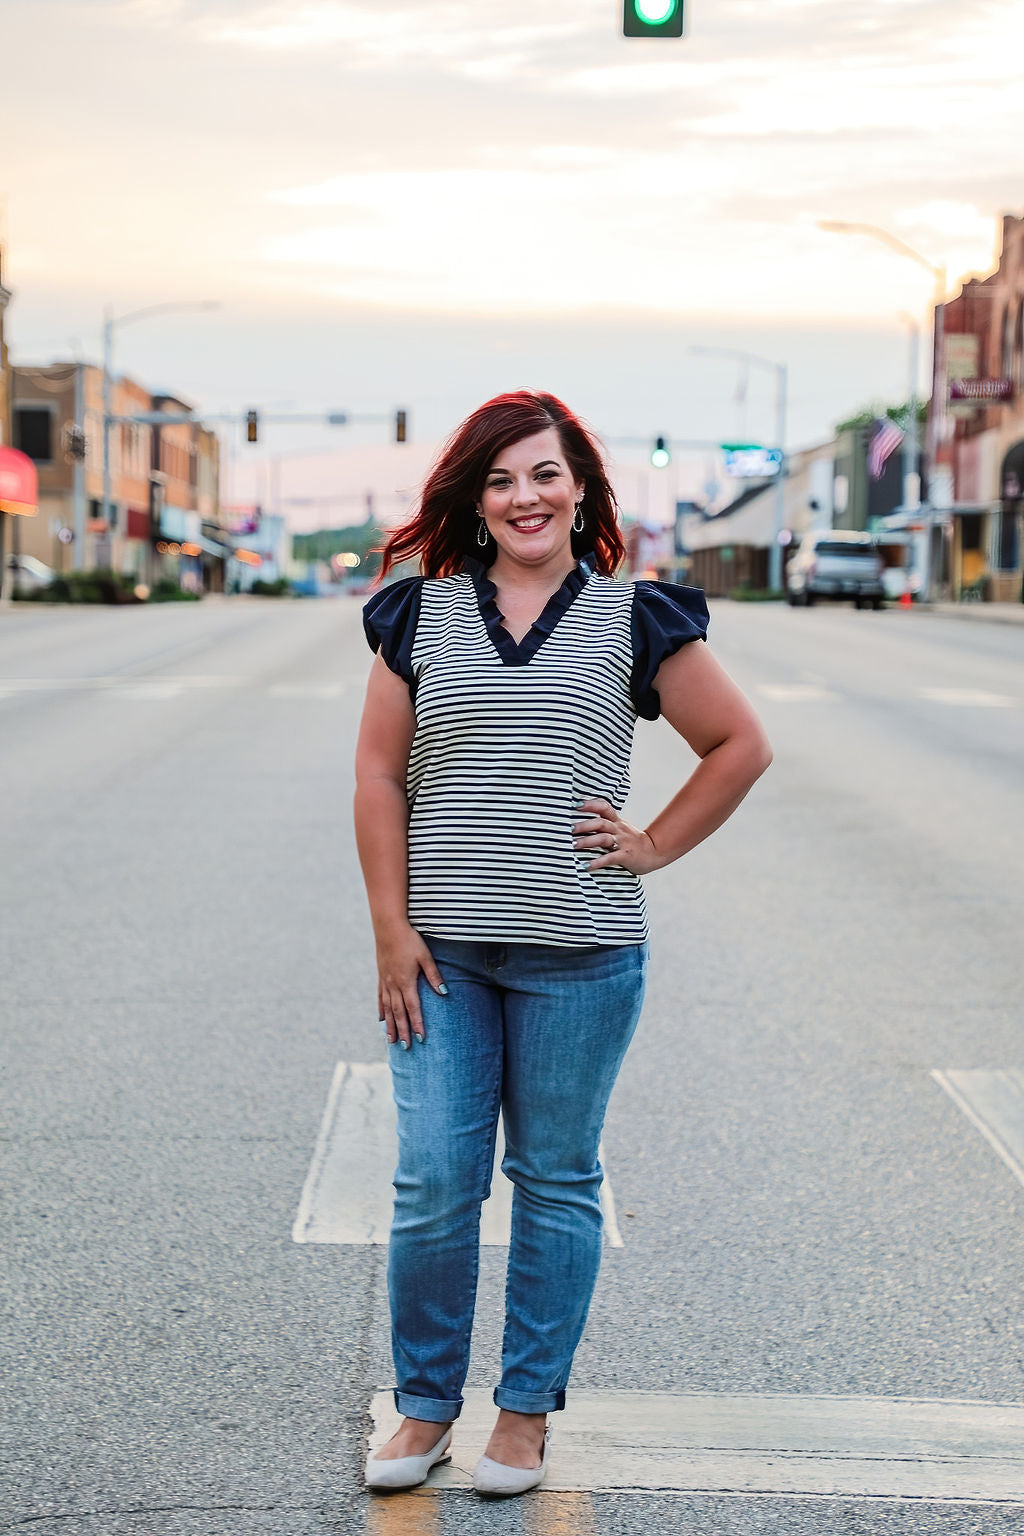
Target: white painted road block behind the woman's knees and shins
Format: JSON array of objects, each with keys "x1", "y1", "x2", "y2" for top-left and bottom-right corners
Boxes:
[{"x1": 292, "y1": 1061, "x2": 623, "y2": 1247}]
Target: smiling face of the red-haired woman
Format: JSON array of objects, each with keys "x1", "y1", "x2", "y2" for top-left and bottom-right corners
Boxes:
[{"x1": 479, "y1": 427, "x2": 583, "y2": 568}]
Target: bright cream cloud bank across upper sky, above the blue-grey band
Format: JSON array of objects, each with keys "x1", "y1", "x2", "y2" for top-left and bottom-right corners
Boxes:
[{"x1": 8, "y1": 0, "x2": 1024, "y2": 331}]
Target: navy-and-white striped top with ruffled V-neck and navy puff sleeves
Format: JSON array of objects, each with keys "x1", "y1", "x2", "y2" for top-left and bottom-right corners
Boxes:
[{"x1": 364, "y1": 556, "x2": 708, "y2": 946}]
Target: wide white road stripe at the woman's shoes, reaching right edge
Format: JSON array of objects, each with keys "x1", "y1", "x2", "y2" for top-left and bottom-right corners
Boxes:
[{"x1": 370, "y1": 1389, "x2": 1024, "y2": 1505}]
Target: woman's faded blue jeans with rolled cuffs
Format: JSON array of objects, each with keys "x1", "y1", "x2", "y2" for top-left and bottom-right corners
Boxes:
[{"x1": 388, "y1": 937, "x2": 648, "y2": 1424}]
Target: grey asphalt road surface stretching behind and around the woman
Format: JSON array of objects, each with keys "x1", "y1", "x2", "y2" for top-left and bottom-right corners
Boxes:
[{"x1": 0, "y1": 599, "x2": 1024, "y2": 1536}]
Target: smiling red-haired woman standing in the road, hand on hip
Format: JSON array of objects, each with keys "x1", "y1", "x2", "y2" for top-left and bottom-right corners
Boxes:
[{"x1": 356, "y1": 390, "x2": 771, "y2": 1495}]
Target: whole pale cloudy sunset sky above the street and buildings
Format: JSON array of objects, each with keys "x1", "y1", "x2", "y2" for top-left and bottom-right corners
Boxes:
[{"x1": 0, "y1": 0, "x2": 1024, "y2": 528}]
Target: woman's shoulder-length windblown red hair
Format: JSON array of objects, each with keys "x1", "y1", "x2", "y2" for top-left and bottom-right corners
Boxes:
[{"x1": 379, "y1": 389, "x2": 626, "y2": 581}]
